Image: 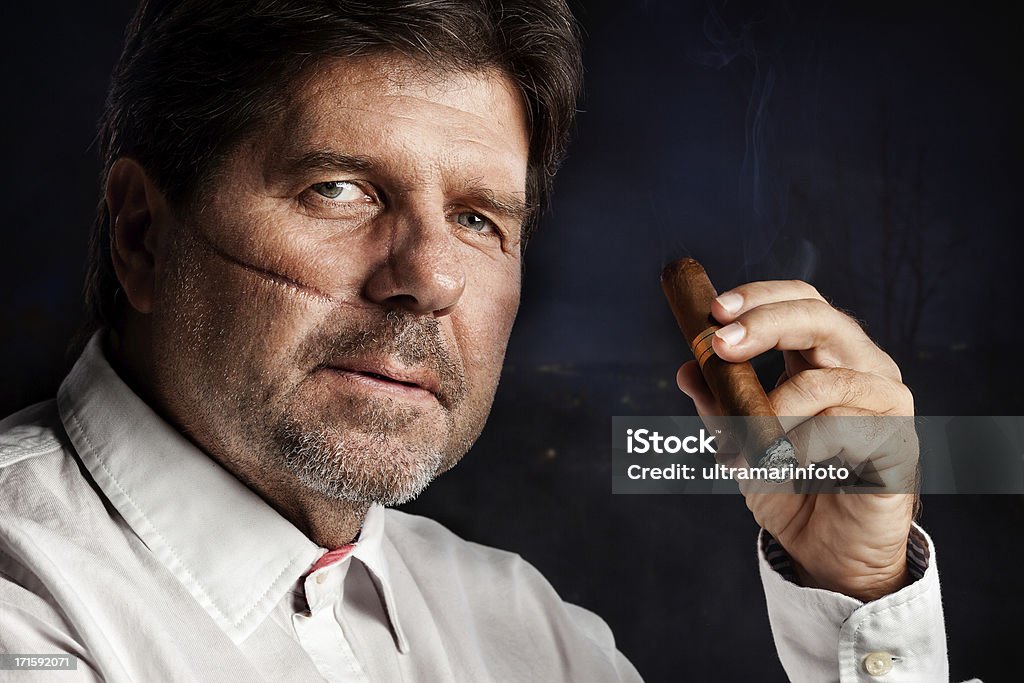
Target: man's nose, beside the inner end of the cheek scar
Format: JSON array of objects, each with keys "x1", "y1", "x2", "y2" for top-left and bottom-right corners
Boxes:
[{"x1": 365, "y1": 210, "x2": 466, "y2": 316}]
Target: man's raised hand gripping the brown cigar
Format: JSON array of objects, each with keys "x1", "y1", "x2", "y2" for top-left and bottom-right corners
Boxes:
[{"x1": 677, "y1": 281, "x2": 916, "y2": 601}]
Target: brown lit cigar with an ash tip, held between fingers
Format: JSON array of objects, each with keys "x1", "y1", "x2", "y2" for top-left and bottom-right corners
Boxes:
[{"x1": 662, "y1": 258, "x2": 798, "y2": 471}]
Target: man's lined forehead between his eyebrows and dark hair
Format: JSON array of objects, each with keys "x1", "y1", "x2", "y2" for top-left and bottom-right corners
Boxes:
[{"x1": 256, "y1": 56, "x2": 529, "y2": 190}]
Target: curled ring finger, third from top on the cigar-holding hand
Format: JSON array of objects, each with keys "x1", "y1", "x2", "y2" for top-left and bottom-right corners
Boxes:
[{"x1": 768, "y1": 368, "x2": 913, "y2": 430}]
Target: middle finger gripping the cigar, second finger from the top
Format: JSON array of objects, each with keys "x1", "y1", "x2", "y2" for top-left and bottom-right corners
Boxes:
[{"x1": 712, "y1": 299, "x2": 900, "y2": 381}]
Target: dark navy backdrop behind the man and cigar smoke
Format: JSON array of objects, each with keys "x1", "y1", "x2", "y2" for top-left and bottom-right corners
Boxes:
[{"x1": 0, "y1": 0, "x2": 1024, "y2": 680}]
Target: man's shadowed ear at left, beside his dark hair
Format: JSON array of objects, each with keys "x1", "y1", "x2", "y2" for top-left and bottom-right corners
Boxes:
[{"x1": 105, "y1": 157, "x2": 168, "y2": 313}]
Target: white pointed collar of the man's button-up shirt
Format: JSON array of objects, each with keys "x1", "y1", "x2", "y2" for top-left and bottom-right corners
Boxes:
[{"x1": 57, "y1": 332, "x2": 406, "y2": 649}]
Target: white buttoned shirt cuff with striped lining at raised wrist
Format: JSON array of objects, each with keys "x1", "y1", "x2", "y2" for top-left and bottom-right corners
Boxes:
[{"x1": 758, "y1": 524, "x2": 949, "y2": 683}]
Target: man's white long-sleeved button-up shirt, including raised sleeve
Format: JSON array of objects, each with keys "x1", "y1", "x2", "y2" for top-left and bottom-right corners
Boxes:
[{"x1": 0, "y1": 335, "x2": 947, "y2": 683}]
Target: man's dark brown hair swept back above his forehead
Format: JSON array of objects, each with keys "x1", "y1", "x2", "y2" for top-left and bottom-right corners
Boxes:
[{"x1": 85, "y1": 0, "x2": 582, "y2": 325}]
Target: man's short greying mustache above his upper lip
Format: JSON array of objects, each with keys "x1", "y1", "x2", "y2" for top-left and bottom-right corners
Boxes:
[{"x1": 302, "y1": 308, "x2": 468, "y2": 409}]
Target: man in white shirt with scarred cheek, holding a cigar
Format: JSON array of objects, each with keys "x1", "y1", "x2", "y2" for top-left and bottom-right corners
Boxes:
[{"x1": 0, "y1": 0, "x2": 946, "y2": 681}]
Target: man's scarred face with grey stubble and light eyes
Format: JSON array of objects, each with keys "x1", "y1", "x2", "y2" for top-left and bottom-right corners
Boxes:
[{"x1": 152, "y1": 57, "x2": 528, "y2": 504}]
